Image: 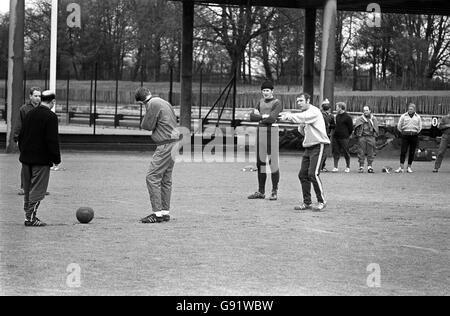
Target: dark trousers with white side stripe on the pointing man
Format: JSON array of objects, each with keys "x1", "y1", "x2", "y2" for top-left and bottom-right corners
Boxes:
[{"x1": 298, "y1": 144, "x2": 329, "y2": 205}]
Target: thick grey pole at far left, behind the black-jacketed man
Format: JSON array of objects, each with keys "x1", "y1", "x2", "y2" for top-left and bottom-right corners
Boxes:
[{"x1": 6, "y1": 0, "x2": 25, "y2": 153}]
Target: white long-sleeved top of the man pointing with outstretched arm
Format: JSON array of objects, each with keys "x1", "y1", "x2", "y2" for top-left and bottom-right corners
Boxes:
[{"x1": 285, "y1": 105, "x2": 331, "y2": 148}]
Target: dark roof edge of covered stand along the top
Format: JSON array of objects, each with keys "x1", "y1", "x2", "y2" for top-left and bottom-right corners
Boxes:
[{"x1": 175, "y1": 0, "x2": 450, "y2": 16}]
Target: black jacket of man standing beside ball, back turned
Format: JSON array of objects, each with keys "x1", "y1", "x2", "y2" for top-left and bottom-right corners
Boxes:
[{"x1": 19, "y1": 106, "x2": 61, "y2": 166}]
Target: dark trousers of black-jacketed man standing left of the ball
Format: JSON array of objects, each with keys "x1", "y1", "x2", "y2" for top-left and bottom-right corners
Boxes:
[{"x1": 22, "y1": 164, "x2": 50, "y2": 221}]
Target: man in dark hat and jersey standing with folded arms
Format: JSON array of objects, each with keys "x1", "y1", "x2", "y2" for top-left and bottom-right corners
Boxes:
[{"x1": 248, "y1": 81, "x2": 283, "y2": 201}]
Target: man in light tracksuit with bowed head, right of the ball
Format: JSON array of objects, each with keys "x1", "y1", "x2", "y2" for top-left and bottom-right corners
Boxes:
[{"x1": 136, "y1": 88, "x2": 180, "y2": 224}]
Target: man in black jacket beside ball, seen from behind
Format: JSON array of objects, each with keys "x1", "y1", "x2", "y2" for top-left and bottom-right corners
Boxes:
[{"x1": 18, "y1": 91, "x2": 61, "y2": 227}]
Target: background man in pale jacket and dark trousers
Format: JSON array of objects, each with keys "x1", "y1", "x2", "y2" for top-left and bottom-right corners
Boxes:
[{"x1": 395, "y1": 103, "x2": 422, "y2": 173}]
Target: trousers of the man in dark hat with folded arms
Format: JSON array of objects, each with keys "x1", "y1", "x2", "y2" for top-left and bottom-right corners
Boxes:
[{"x1": 256, "y1": 126, "x2": 280, "y2": 194}]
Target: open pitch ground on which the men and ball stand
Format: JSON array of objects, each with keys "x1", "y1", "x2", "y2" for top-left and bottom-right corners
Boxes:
[{"x1": 0, "y1": 152, "x2": 450, "y2": 296}]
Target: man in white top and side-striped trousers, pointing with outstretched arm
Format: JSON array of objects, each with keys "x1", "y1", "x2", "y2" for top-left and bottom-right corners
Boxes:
[{"x1": 281, "y1": 93, "x2": 331, "y2": 212}]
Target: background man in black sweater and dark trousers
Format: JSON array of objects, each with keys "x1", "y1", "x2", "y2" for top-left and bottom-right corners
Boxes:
[{"x1": 332, "y1": 102, "x2": 353, "y2": 173}]
